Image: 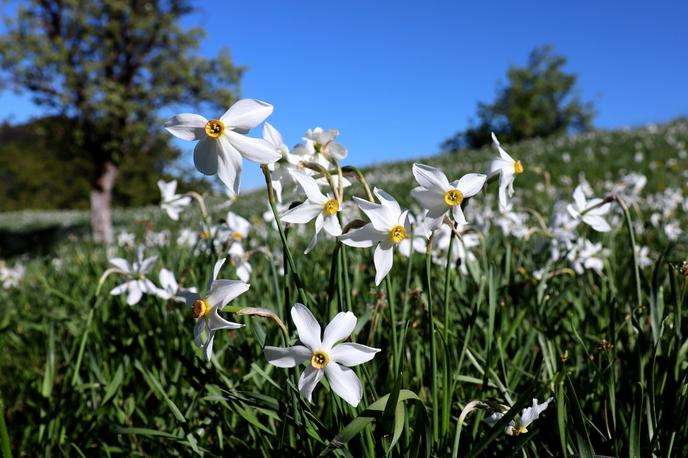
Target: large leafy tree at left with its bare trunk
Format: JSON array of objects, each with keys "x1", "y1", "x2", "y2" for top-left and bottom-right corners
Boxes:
[{"x1": 0, "y1": 0, "x2": 243, "y2": 243}]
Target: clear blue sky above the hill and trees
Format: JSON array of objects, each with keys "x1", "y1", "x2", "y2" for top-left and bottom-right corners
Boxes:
[{"x1": 0, "y1": 0, "x2": 688, "y2": 189}]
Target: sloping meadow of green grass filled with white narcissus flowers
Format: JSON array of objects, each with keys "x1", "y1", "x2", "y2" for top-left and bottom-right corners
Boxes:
[{"x1": 0, "y1": 106, "x2": 688, "y2": 457}]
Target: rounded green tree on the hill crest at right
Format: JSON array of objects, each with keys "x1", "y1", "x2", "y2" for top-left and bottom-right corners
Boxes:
[{"x1": 442, "y1": 46, "x2": 595, "y2": 150}]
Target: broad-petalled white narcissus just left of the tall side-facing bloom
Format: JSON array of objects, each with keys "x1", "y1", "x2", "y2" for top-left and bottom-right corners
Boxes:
[{"x1": 411, "y1": 164, "x2": 487, "y2": 227}]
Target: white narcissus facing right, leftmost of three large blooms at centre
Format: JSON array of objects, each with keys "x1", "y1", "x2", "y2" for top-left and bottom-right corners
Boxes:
[{"x1": 282, "y1": 172, "x2": 342, "y2": 253}]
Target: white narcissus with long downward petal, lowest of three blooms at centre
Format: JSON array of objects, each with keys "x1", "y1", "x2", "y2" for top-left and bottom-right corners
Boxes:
[{"x1": 339, "y1": 188, "x2": 411, "y2": 285}]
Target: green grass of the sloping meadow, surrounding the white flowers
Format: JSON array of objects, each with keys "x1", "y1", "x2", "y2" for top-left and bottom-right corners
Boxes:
[{"x1": 0, "y1": 121, "x2": 688, "y2": 457}]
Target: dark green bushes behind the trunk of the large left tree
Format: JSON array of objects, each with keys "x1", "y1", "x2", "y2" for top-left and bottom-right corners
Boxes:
[{"x1": 0, "y1": 116, "x2": 196, "y2": 211}]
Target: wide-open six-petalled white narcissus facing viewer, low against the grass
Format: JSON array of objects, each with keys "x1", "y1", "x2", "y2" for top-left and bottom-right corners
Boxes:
[{"x1": 265, "y1": 304, "x2": 380, "y2": 407}]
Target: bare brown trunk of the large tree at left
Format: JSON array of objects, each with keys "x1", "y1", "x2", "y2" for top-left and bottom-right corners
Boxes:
[{"x1": 91, "y1": 161, "x2": 117, "y2": 245}]
